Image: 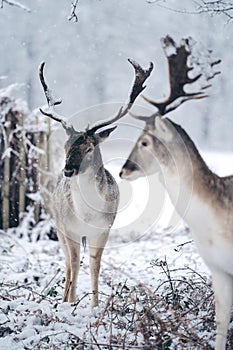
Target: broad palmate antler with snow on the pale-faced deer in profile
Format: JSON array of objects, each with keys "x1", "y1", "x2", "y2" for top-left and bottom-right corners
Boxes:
[{"x1": 142, "y1": 35, "x2": 221, "y2": 115}]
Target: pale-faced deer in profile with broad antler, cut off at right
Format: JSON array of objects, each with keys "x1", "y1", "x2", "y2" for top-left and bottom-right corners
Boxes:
[{"x1": 119, "y1": 36, "x2": 233, "y2": 350}]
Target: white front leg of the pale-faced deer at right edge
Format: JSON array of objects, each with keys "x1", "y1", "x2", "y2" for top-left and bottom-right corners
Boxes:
[{"x1": 212, "y1": 270, "x2": 233, "y2": 350}]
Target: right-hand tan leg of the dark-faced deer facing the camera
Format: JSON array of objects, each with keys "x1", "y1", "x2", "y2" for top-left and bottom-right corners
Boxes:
[{"x1": 89, "y1": 232, "x2": 109, "y2": 307}]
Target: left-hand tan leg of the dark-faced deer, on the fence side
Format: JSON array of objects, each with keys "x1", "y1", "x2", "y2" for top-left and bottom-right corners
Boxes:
[{"x1": 63, "y1": 237, "x2": 80, "y2": 303}]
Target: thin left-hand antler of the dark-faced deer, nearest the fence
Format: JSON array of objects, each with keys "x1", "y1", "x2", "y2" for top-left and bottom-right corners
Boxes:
[{"x1": 39, "y1": 62, "x2": 74, "y2": 134}]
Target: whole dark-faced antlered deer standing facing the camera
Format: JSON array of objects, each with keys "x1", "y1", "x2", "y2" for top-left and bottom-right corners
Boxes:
[{"x1": 39, "y1": 59, "x2": 153, "y2": 307}]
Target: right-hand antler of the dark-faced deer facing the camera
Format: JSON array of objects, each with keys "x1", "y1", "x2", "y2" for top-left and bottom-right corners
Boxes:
[{"x1": 89, "y1": 58, "x2": 154, "y2": 133}]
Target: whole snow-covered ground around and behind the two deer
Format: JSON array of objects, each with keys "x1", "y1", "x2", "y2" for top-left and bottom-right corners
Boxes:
[{"x1": 0, "y1": 153, "x2": 233, "y2": 350}]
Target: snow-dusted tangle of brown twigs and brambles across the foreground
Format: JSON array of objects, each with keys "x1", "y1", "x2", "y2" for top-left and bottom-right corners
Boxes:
[{"x1": 0, "y1": 259, "x2": 227, "y2": 350}]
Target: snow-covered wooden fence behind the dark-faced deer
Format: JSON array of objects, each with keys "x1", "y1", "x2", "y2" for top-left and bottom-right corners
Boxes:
[{"x1": 0, "y1": 94, "x2": 50, "y2": 229}]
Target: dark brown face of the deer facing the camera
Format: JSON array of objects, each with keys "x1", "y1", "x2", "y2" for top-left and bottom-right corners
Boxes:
[{"x1": 64, "y1": 131, "x2": 98, "y2": 177}]
